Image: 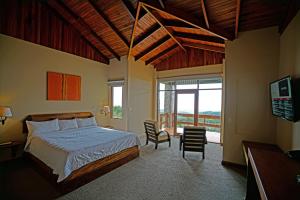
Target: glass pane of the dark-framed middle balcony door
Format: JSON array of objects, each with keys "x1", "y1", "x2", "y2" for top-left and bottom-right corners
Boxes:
[{"x1": 176, "y1": 94, "x2": 195, "y2": 133}]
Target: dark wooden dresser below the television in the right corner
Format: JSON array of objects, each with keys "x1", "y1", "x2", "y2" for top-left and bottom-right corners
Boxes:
[{"x1": 243, "y1": 141, "x2": 300, "y2": 200}]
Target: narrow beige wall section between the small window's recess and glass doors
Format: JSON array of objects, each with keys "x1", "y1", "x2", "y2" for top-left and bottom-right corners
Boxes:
[{"x1": 127, "y1": 57, "x2": 156, "y2": 135}]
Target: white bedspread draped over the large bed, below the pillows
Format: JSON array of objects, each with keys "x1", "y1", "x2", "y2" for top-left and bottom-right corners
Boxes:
[{"x1": 25, "y1": 126, "x2": 140, "y2": 182}]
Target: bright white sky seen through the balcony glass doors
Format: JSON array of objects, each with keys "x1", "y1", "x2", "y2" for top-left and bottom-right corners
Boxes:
[{"x1": 159, "y1": 84, "x2": 222, "y2": 113}]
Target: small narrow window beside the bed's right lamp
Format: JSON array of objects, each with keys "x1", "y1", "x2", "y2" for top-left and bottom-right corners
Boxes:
[{"x1": 112, "y1": 86, "x2": 123, "y2": 119}]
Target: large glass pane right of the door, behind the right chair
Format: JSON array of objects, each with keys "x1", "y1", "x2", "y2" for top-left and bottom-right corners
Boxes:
[{"x1": 198, "y1": 90, "x2": 222, "y2": 133}]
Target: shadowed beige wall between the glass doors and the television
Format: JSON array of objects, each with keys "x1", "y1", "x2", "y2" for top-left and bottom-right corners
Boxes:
[{"x1": 223, "y1": 27, "x2": 279, "y2": 164}]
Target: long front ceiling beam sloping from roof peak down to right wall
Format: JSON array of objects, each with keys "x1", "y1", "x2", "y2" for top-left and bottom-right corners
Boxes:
[{"x1": 140, "y1": 0, "x2": 234, "y2": 40}]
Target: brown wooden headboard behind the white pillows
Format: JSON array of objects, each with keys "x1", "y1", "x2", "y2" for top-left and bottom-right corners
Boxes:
[{"x1": 23, "y1": 112, "x2": 94, "y2": 133}]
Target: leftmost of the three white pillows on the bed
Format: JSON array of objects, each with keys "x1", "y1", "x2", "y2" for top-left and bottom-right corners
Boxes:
[{"x1": 26, "y1": 119, "x2": 59, "y2": 133}]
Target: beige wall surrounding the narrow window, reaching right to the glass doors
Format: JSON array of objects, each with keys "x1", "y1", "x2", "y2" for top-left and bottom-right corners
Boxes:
[{"x1": 108, "y1": 56, "x2": 156, "y2": 135}]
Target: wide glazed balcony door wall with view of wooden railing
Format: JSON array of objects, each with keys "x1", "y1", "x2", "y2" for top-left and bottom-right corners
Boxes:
[{"x1": 157, "y1": 77, "x2": 222, "y2": 143}]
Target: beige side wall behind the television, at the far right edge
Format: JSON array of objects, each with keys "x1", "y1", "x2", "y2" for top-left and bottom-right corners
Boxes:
[{"x1": 276, "y1": 12, "x2": 300, "y2": 151}]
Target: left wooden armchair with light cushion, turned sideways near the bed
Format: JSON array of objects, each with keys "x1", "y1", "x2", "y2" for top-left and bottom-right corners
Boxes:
[{"x1": 144, "y1": 120, "x2": 171, "y2": 149}]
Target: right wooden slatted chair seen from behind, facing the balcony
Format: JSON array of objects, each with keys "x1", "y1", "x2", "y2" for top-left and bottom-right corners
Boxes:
[{"x1": 182, "y1": 126, "x2": 207, "y2": 159}]
